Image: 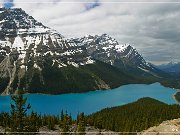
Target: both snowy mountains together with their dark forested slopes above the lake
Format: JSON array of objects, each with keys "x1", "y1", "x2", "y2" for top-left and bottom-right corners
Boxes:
[{"x1": 0, "y1": 8, "x2": 176, "y2": 95}]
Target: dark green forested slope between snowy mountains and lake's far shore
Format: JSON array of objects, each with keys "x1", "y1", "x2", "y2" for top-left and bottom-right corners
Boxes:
[{"x1": 10, "y1": 60, "x2": 156, "y2": 94}]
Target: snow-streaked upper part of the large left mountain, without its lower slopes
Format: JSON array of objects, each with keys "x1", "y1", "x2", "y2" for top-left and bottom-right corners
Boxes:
[{"x1": 0, "y1": 8, "x2": 93, "y2": 67}]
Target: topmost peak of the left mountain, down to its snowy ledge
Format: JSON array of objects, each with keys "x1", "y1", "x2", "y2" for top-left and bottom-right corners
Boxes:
[{"x1": 0, "y1": 8, "x2": 49, "y2": 37}]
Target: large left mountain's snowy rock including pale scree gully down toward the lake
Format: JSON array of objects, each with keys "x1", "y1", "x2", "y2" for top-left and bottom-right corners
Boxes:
[{"x1": 0, "y1": 8, "x2": 94, "y2": 94}]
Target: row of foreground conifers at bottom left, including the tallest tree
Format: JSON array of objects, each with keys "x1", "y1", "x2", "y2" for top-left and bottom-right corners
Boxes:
[{"x1": 0, "y1": 91, "x2": 86, "y2": 135}]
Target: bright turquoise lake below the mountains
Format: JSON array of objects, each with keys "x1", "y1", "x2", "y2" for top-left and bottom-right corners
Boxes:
[{"x1": 0, "y1": 83, "x2": 177, "y2": 117}]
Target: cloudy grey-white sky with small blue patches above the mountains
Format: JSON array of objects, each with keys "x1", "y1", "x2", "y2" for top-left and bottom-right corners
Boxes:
[{"x1": 1, "y1": 0, "x2": 180, "y2": 64}]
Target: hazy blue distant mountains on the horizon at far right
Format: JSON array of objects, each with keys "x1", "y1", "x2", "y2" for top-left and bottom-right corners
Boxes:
[{"x1": 158, "y1": 62, "x2": 180, "y2": 74}]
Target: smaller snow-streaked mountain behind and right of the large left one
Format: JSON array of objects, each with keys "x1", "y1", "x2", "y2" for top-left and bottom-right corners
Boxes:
[{"x1": 71, "y1": 34, "x2": 159, "y2": 74}]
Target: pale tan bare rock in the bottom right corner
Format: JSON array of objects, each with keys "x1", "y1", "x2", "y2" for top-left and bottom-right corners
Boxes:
[{"x1": 138, "y1": 118, "x2": 180, "y2": 135}]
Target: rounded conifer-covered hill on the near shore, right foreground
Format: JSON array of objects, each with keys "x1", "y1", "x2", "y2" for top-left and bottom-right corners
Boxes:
[{"x1": 87, "y1": 98, "x2": 180, "y2": 132}]
